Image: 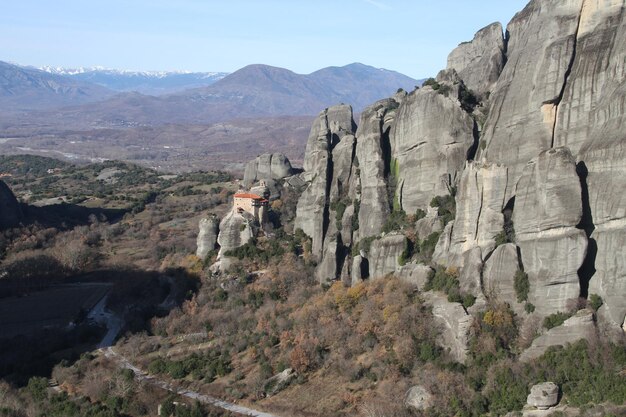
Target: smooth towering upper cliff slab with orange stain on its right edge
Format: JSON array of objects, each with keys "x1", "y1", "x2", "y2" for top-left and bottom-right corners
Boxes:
[{"x1": 484, "y1": 0, "x2": 583, "y2": 200}]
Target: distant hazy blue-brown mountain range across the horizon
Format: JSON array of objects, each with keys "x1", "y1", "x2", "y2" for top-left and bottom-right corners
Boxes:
[{"x1": 0, "y1": 63, "x2": 419, "y2": 128}]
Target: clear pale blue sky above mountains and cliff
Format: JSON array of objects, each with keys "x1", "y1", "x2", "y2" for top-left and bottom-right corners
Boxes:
[{"x1": 0, "y1": 0, "x2": 527, "y2": 78}]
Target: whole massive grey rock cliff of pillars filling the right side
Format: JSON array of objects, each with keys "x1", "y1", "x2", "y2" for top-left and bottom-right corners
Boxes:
[{"x1": 296, "y1": 0, "x2": 626, "y2": 333}]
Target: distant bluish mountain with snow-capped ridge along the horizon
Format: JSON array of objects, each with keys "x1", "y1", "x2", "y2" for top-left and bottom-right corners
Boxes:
[{"x1": 39, "y1": 66, "x2": 228, "y2": 95}]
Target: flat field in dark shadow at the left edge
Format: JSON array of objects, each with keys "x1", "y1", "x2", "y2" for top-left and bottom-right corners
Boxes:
[{"x1": 0, "y1": 283, "x2": 110, "y2": 338}]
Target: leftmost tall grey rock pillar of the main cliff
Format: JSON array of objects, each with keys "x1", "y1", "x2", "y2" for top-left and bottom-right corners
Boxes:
[{"x1": 295, "y1": 105, "x2": 354, "y2": 260}]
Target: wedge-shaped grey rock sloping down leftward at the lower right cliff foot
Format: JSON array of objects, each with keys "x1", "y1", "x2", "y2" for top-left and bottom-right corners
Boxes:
[{"x1": 520, "y1": 309, "x2": 596, "y2": 362}]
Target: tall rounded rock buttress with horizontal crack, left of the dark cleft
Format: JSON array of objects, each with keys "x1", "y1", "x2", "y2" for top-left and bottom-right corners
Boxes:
[{"x1": 513, "y1": 148, "x2": 587, "y2": 315}]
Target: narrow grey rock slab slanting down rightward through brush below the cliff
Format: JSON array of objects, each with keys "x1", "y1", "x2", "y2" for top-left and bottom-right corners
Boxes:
[{"x1": 424, "y1": 292, "x2": 473, "y2": 363}]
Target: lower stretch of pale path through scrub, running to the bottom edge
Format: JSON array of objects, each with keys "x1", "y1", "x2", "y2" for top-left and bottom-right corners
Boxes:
[{"x1": 102, "y1": 347, "x2": 279, "y2": 417}]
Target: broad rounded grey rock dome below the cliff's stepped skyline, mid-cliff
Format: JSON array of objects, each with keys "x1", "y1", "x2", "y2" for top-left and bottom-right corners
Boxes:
[{"x1": 391, "y1": 87, "x2": 474, "y2": 213}]
